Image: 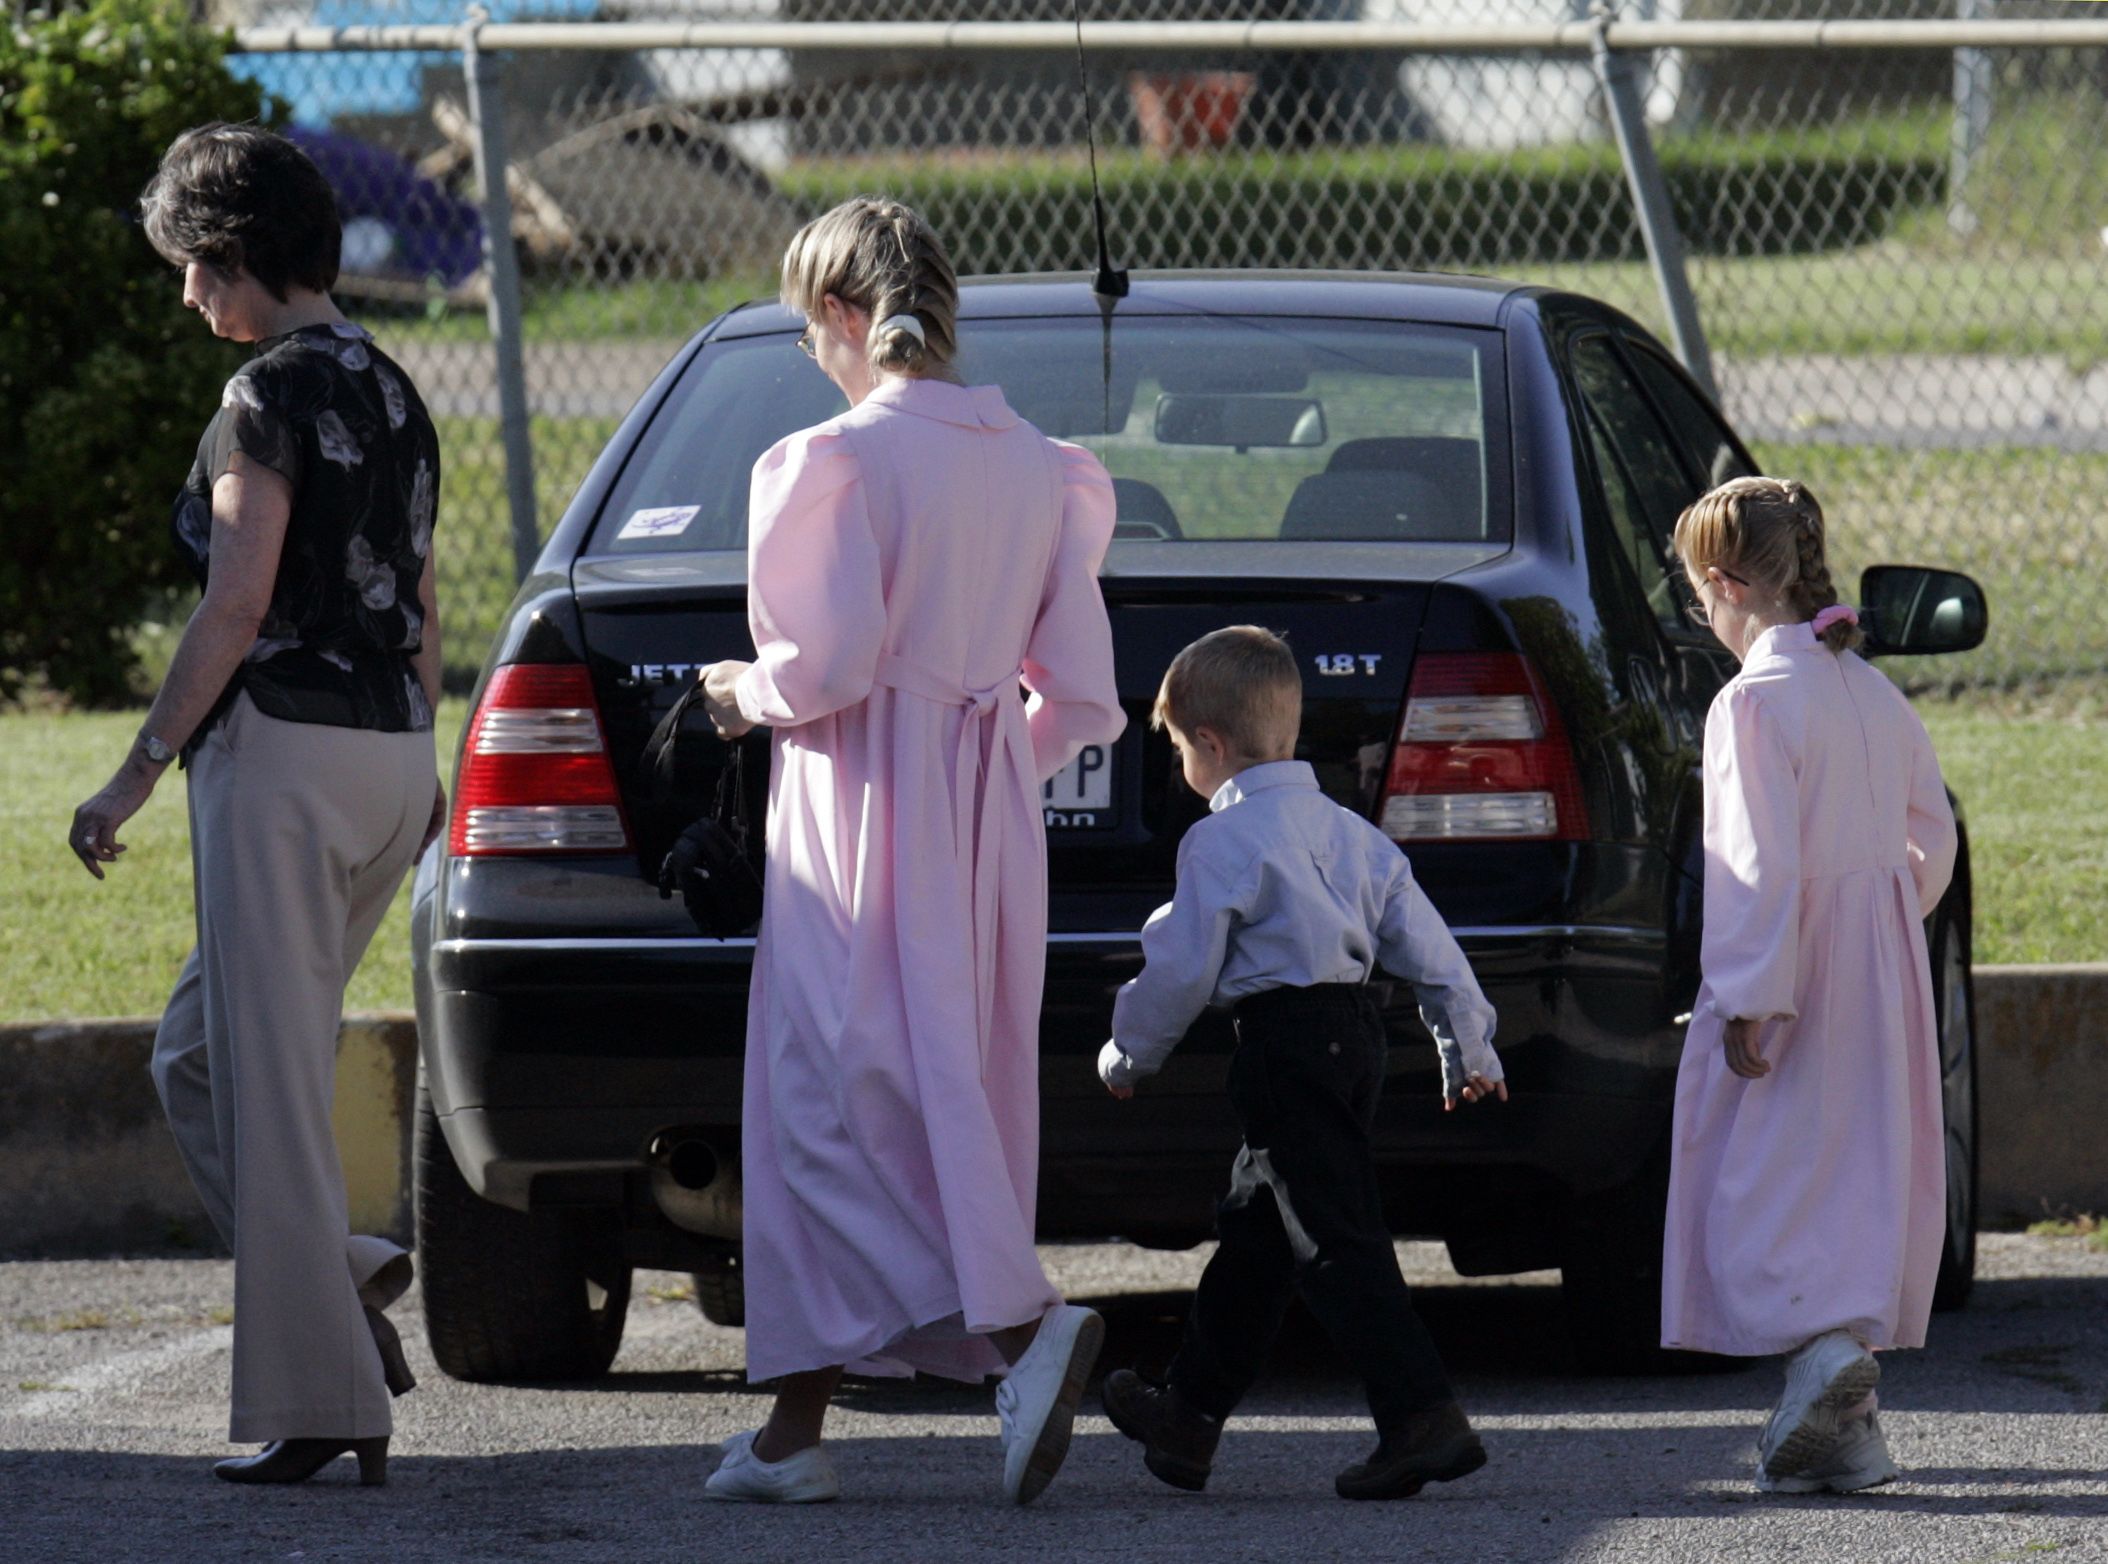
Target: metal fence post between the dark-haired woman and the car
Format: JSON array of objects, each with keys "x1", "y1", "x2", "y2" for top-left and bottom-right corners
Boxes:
[{"x1": 462, "y1": 6, "x2": 542, "y2": 580}]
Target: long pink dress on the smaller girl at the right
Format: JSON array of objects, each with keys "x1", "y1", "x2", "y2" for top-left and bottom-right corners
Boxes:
[{"x1": 1661, "y1": 624, "x2": 1954, "y2": 1357}]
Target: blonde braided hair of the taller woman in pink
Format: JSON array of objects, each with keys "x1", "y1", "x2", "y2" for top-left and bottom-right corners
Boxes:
[{"x1": 782, "y1": 196, "x2": 959, "y2": 379}]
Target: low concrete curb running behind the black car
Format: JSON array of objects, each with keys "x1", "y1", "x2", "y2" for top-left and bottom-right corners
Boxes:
[{"x1": 0, "y1": 963, "x2": 2108, "y2": 1256}]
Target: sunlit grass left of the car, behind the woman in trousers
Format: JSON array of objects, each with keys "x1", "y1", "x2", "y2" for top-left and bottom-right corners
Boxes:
[{"x1": 0, "y1": 700, "x2": 468, "y2": 1020}]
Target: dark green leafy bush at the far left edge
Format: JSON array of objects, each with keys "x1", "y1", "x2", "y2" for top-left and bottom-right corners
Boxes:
[{"x1": 0, "y1": 0, "x2": 266, "y2": 702}]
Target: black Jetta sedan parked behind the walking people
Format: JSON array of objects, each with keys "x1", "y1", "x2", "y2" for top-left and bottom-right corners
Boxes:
[{"x1": 413, "y1": 272, "x2": 1984, "y2": 1379}]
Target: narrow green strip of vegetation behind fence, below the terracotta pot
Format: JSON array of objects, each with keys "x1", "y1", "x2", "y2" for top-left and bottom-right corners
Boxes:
[{"x1": 778, "y1": 120, "x2": 1946, "y2": 272}]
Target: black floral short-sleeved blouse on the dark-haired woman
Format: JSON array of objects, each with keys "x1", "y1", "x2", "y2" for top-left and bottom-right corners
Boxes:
[{"x1": 175, "y1": 325, "x2": 438, "y2": 734}]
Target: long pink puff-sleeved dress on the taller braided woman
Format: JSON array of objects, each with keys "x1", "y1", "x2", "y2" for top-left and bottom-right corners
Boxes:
[{"x1": 738, "y1": 379, "x2": 1126, "y2": 1381}]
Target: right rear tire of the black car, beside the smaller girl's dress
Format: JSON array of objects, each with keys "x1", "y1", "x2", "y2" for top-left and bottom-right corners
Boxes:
[{"x1": 1560, "y1": 1134, "x2": 1697, "y2": 1374}]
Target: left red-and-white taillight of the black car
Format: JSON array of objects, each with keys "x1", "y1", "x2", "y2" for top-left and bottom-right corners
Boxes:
[{"x1": 447, "y1": 662, "x2": 630, "y2": 858}]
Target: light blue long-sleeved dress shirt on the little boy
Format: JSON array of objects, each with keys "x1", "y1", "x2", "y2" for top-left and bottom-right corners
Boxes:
[{"x1": 1098, "y1": 761, "x2": 1503, "y2": 1096}]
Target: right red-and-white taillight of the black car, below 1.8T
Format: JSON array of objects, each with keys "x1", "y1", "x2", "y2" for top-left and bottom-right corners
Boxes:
[{"x1": 1381, "y1": 651, "x2": 1587, "y2": 841}]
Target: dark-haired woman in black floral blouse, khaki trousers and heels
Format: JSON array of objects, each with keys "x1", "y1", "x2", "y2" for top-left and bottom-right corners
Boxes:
[{"x1": 70, "y1": 124, "x2": 447, "y2": 1482}]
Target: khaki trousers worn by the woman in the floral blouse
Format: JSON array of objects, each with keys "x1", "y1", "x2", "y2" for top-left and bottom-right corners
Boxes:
[{"x1": 154, "y1": 696, "x2": 436, "y2": 1444}]
